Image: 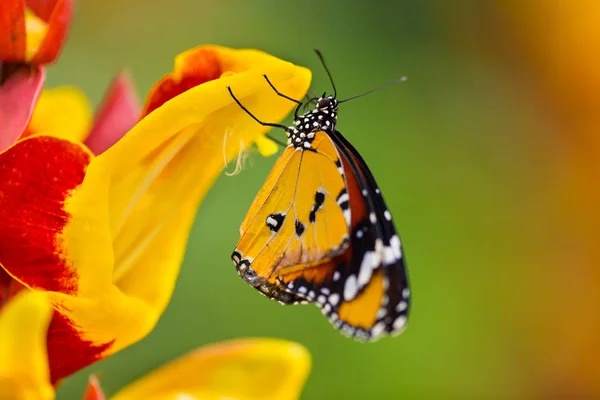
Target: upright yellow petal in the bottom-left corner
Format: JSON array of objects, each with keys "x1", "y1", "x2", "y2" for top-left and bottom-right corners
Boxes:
[{"x1": 0, "y1": 291, "x2": 54, "y2": 400}]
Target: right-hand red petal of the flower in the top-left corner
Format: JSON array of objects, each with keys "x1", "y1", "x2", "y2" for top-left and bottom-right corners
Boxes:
[{"x1": 30, "y1": 0, "x2": 74, "y2": 65}]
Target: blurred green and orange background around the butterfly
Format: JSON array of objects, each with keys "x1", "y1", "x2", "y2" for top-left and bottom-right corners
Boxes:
[{"x1": 48, "y1": 0, "x2": 600, "y2": 399}]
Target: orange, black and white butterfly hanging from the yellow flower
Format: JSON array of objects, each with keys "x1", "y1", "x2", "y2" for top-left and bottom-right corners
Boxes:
[{"x1": 228, "y1": 50, "x2": 410, "y2": 341}]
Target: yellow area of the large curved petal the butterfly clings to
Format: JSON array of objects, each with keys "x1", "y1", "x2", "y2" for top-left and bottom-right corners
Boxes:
[{"x1": 57, "y1": 46, "x2": 310, "y2": 352}]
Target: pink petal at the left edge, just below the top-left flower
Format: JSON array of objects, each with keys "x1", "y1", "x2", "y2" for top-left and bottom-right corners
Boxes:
[{"x1": 0, "y1": 67, "x2": 46, "y2": 151}]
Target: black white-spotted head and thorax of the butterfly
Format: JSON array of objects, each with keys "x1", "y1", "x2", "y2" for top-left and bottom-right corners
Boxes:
[{"x1": 286, "y1": 96, "x2": 338, "y2": 149}]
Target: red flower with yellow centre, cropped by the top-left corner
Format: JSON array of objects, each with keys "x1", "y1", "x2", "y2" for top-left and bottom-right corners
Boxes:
[{"x1": 0, "y1": 0, "x2": 74, "y2": 65}]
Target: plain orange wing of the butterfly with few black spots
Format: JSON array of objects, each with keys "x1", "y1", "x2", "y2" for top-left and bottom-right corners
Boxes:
[{"x1": 232, "y1": 132, "x2": 350, "y2": 304}]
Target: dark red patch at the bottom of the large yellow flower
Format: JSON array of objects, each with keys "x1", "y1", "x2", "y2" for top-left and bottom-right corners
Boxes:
[{"x1": 48, "y1": 312, "x2": 113, "y2": 384}]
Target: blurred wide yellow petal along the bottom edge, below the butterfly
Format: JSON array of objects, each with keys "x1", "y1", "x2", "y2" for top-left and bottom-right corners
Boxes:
[{"x1": 111, "y1": 339, "x2": 310, "y2": 400}]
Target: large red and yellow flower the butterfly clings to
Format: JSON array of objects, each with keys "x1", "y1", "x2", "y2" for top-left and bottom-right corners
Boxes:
[{"x1": 0, "y1": 46, "x2": 310, "y2": 383}]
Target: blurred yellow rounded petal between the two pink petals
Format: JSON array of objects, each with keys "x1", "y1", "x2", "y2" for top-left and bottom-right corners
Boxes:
[{"x1": 24, "y1": 86, "x2": 92, "y2": 143}]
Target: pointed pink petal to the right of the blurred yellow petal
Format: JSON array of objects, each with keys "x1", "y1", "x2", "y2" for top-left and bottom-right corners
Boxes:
[{"x1": 85, "y1": 72, "x2": 141, "y2": 154}]
